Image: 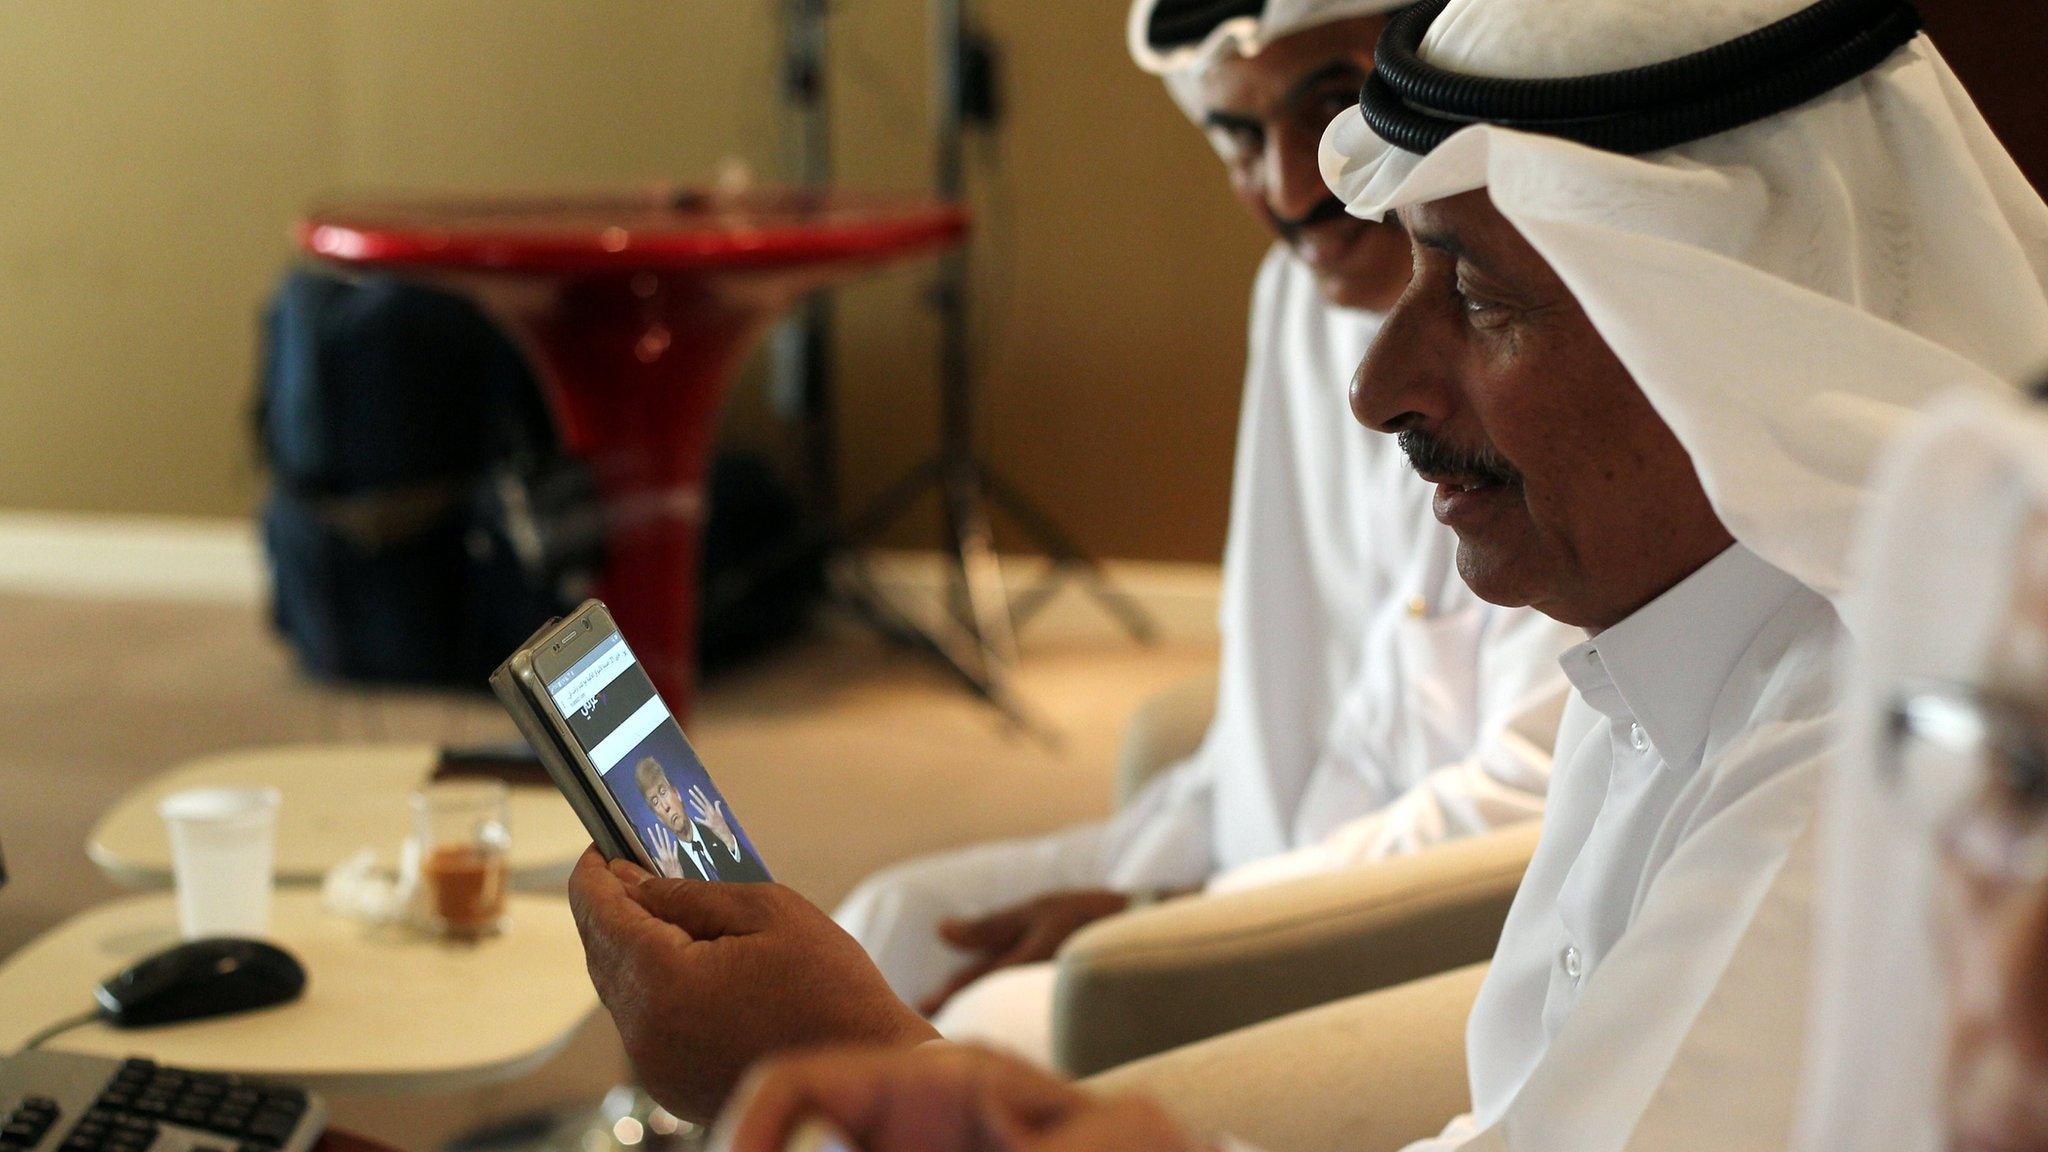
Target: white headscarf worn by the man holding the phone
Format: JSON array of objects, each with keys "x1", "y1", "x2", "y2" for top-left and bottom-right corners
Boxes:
[{"x1": 1323, "y1": 0, "x2": 2048, "y2": 596}]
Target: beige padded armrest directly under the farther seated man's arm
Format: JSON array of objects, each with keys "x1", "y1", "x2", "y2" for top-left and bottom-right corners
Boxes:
[{"x1": 1053, "y1": 820, "x2": 1540, "y2": 1076}]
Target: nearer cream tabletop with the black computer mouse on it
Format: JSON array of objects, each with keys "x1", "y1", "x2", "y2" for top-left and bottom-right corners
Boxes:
[{"x1": 0, "y1": 892, "x2": 598, "y2": 1093}]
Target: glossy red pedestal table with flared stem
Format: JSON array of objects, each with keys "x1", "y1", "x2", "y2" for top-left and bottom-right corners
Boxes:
[{"x1": 299, "y1": 193, "x2": 967, "y2": 717}]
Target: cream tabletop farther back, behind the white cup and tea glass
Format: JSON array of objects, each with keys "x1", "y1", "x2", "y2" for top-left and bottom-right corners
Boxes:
[{"x1": 86, "y1": 744, "x2": 590, "y2": 892}]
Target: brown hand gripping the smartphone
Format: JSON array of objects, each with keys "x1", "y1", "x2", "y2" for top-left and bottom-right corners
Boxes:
[{"x1": 569, "y1": 849, "x2": 938, "y2": 1121}]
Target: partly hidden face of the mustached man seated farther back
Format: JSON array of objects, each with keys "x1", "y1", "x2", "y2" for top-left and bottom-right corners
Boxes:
[{"x1": 1200, "y1": 16, "x2": 1409, "y2": 312}]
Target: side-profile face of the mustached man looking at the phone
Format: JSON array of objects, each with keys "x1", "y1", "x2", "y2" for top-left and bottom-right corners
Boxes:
[{"x1": 1352, "y1": 193, "x2": 1733, "y2": 631}]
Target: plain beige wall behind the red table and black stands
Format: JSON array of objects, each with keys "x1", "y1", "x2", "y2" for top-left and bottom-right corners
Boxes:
[{"x1": 0, "y1": 0, "x2": 1269, "y2": 560}]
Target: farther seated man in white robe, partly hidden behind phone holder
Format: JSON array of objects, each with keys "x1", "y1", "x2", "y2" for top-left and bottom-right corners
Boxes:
[{"x1": 838, "y1": 0, "x2": 1575, "y2": 1062}]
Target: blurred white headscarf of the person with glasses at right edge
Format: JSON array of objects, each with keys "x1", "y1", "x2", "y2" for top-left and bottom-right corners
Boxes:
[{"x1": 1796, "y1": 389, "x2": 2048, "y2": 1152}]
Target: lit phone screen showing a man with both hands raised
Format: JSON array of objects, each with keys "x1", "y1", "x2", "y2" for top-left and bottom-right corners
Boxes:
[{"x1": 547, "y1": 631, "x2": 770, "y2": 881}]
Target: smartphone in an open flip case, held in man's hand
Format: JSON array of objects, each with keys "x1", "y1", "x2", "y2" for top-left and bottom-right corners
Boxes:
[{"x1": 492, "y1": 601, "x2": 772, "y2": 883}]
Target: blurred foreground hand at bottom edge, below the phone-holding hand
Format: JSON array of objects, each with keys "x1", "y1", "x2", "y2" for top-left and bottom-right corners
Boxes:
[{"x1": 713, "y1": 1043, "x2": 1204, "y2": 1152}]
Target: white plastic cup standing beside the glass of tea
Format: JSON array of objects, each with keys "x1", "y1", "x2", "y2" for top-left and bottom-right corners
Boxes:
[{"x1": 156, "y1": 787, "x2": 283, "y2": 941}]
